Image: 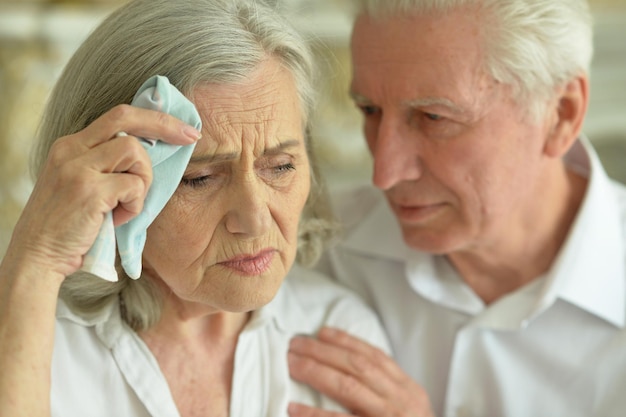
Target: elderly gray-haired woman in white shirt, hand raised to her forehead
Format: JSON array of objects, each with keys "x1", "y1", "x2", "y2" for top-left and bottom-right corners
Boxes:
[{"x1": 0, "y1": 0, "x2": 386, "y2": 417}]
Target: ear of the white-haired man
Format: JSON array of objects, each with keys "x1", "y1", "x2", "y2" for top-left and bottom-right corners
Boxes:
[{"x1": 544, "y1": 75, "x2": 589, "y2": 158}]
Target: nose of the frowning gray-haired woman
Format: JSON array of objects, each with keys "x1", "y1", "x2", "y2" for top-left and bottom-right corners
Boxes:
[{"x1": 226, "y1": 174, "x2": 272, "y2": 237}]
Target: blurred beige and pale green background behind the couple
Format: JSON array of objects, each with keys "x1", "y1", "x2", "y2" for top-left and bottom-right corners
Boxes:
[{"x1": 0, "y1": 0, "x2": 626, "y2": 258}]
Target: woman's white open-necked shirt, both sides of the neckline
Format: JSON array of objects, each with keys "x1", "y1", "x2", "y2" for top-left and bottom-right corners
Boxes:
[{"x1": 51, "y1": 266, "x2": 389, "y2": 417}]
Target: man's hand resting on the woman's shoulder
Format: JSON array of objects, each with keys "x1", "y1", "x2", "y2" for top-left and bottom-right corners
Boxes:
[{"x1": 289, "y1": 328, "x2": 433, "y2": 417}]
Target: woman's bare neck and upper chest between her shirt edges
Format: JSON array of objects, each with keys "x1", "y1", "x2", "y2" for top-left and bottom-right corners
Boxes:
[{"x1": 139, "y1": 286, "x2": 251, "y2": 417}]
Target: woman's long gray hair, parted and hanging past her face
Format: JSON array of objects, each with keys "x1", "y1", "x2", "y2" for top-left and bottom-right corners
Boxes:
[{"x1": 33, "y1": 0, "x2": 335, "y2": 330}]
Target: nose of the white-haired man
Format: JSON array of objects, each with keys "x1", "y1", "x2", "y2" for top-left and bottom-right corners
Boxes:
[{"x1": 369, "y1": 116, "x2": 422, "y2": 190}]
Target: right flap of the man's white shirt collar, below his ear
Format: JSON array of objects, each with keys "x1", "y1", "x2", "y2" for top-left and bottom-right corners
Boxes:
[{"x1": 535, "y1": 137, "x2": 626, "y2": 327}]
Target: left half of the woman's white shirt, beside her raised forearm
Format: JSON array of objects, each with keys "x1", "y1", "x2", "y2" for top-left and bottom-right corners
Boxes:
[{"x1": 51, "y1": 300, "x2": 168, "y2": 417}]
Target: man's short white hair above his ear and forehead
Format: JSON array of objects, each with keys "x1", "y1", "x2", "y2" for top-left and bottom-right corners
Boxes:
[{"x1": 354, "y1": 0, "x2": 593, "y2": 121}]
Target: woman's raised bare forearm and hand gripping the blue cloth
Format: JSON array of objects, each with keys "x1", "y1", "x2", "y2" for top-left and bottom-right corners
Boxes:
[{"x1": 0, "y1": 105, "x2": 199, "y2": 417}]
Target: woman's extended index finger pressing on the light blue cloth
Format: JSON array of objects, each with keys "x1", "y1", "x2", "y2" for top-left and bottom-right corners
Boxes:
[{"x1": 81, "y1": 104, "x2": 200, "y2": 148}]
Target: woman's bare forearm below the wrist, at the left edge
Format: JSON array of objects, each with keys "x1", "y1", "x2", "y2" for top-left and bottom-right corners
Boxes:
[{"x1": 0, "y1": 247, "x2": 64, "y2": 416}]
